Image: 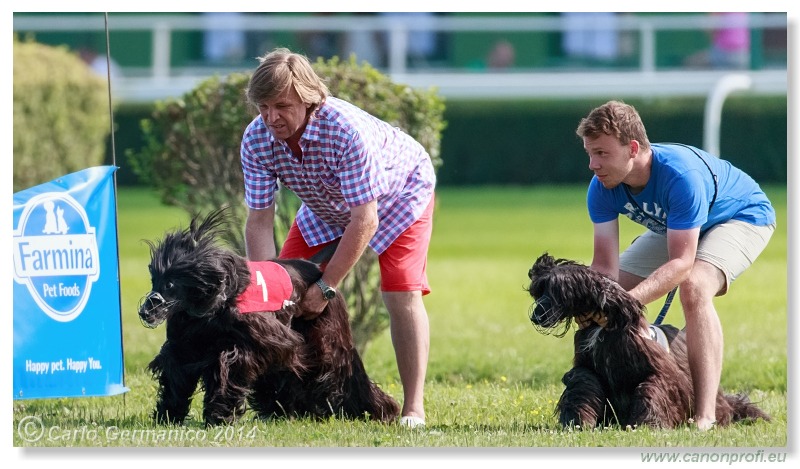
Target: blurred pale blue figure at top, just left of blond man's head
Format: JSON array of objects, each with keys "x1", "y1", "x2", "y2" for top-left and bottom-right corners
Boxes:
[{"x1": 203, "y1": 12, "x2": 246, "y2": 64}]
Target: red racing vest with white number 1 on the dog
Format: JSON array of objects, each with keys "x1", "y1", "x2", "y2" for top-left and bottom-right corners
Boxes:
[{"x1": 236, "y1": 261, "x2": 294, "y2": 313}]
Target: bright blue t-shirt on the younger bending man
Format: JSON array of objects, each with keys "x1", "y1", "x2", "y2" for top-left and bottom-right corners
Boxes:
[{"x1": 586, "y1": 143, "x2": 775, "y2": 234}]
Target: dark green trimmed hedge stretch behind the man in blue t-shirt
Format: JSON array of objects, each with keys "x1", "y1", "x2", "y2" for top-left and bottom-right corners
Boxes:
[{"x1": 438, "y1": 97, "x2": 787, "y2": 185}]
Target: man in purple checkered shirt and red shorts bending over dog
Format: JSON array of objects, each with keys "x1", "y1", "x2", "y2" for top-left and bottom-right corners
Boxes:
[{"x1": 241, "y1": 48, "x2": 436, "y2": 427}]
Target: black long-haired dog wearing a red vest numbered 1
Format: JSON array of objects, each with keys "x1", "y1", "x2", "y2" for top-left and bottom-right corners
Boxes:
[{"x1": 139, "y1": 210, "x2": 400, "y2": 425}]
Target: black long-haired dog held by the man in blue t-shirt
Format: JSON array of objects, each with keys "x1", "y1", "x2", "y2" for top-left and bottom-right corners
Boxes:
[{"x1": 528, "y1": 253, "x2": 770, "y2": 428}]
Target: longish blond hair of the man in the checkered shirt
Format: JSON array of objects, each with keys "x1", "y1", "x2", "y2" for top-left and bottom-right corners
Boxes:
[{"x1": 245, "y1": 47, "x2": 328, "y2": 113}]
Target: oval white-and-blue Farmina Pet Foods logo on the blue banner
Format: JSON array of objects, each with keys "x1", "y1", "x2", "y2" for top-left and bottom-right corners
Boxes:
[{"x1": 14, "y1": 192, "x2": 100, "y2": 322}]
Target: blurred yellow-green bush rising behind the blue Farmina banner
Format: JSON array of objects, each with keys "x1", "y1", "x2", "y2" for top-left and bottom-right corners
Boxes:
[{"x1": 13, "y1": 37, "x2": 110, "y2": 192}]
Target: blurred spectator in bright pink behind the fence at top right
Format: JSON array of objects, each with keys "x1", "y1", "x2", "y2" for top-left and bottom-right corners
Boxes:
[{"x1": 685, "y1": 12, "x2": 750, "y2": 69}]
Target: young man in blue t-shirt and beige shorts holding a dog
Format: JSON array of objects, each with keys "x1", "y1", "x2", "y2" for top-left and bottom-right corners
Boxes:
[{"x1": 576, "y1": 101, "x2": 775, "y2": 430}]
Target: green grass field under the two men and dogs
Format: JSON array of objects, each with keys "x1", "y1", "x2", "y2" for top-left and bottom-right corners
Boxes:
[{"x1": 13, "y1": 186, "x2": 789, "y2": 454}]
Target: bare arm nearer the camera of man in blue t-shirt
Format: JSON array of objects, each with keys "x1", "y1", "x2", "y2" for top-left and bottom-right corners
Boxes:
[{"x1": 630, "y1": 228, "x2": 700, "y2": 305}]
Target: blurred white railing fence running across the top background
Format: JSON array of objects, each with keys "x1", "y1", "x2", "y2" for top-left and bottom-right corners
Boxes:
[{"x1": 14, "y1": 13, "x2": 788, "y2": 102}]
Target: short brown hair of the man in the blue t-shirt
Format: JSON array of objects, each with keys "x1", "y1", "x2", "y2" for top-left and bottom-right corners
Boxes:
[{"x1": 575, "y1": 101, "x2": 650, "y2": 149}]
